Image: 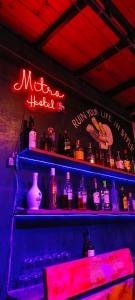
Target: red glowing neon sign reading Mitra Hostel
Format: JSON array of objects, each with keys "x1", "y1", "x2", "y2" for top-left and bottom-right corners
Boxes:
[{"x1": 13, "y1": 69, "x2": 65, "y2": 111}]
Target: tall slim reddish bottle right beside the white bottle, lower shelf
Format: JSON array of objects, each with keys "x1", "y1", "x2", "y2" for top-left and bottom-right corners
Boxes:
[{"x1": 49, "y1": 168, "x2": 57, "y2": 209}]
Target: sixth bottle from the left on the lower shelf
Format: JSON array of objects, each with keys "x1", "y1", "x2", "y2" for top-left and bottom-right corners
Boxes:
[{"x1": 101, "y1": 180, "x2": 111, "y2": 210}]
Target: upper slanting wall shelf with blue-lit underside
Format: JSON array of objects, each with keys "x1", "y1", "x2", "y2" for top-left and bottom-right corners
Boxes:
[{"x1": 17, "y1": 148, "x2": 135, "y2": 183}]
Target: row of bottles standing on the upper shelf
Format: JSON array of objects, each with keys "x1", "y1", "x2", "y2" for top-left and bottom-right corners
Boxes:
[{"x1": 20, "y1": 117, "x2": 135, "y2": 173}]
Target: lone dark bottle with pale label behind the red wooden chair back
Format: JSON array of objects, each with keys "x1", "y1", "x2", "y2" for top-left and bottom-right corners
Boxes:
[{"x1": 83, "y1": 231, "x2": 95, "y2": 257}]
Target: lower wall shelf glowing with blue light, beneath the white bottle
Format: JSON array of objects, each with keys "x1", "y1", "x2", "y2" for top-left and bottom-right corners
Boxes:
[{"x1": 15, "y1": 209, "x2": 135, "y2": 228}]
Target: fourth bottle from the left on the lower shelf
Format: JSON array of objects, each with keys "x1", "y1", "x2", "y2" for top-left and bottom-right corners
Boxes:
[{"x1": 78, "y1": 176, "x2": 87, "y2": 209}]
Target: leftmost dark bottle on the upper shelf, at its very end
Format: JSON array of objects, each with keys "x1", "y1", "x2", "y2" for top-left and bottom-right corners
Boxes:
[{"x1": 19, "y1": 120, "x2": 29, "y2": 151}]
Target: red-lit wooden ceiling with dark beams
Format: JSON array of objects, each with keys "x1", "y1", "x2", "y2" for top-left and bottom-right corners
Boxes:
[{"x1": 0, "y1": 0, "x2": 135, "y2": 108}]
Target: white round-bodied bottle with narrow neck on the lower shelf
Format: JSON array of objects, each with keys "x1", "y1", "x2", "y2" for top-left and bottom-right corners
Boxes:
[{"x1": 27, "y1": 173, "x2": 42, "y2": 209}]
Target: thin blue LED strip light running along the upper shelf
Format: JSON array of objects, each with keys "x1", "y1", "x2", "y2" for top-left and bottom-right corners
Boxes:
[{"x1": 19, "y1": 156, "x2": 135, "y2": 183}]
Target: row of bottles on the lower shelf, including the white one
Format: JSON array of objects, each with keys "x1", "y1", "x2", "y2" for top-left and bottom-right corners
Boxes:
[{"x1": 27, "y1": 168, "x2": 135, "y2": 211}]
